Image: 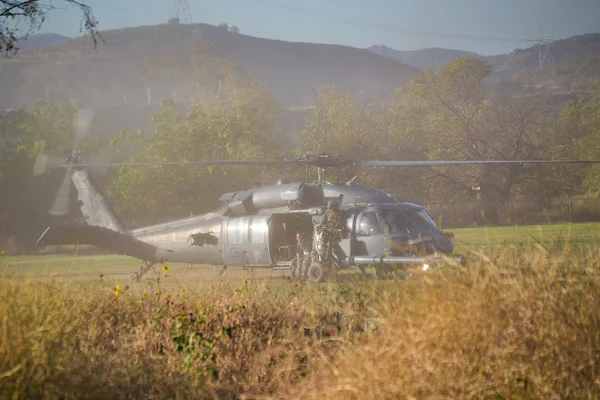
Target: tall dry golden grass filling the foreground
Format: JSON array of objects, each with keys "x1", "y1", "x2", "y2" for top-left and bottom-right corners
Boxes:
[{"x1": 0, "y1": 239, "x2": 600, "y2": 399}]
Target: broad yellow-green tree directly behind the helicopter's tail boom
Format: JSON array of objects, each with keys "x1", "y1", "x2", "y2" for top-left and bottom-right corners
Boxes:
[{"x1": 108, "y1": 76, "x2": 288, "y2": 221}]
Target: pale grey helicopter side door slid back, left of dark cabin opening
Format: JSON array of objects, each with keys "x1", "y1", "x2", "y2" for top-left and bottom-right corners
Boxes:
[{"x1": 225, "y1": 215, "x2": 271, "y2": 266}]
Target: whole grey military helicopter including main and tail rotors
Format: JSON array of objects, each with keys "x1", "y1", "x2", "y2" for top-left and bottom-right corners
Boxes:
[{"x1": 34, "y1": 108, "x2": 600, "y2": 282}]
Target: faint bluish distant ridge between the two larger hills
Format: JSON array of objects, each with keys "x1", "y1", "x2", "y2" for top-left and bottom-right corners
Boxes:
[{"x1": 368, "y1": 45, "x2": 506, "y2": 68}]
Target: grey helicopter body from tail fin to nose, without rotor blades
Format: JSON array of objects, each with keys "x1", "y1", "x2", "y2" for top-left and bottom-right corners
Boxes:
[{"x1": 38, "y1": 169, "x2": 462, "y2": 267}]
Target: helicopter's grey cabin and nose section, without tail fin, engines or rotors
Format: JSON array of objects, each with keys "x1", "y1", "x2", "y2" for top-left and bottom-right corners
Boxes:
[{"x1": 131, "y1": 202, "x2": 454, "y2": 267}]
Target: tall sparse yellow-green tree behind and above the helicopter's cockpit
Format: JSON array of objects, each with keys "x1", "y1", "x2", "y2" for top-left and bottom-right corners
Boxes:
[{"x1": 396, "y1": 56, "x2": 551, "y2": 222}]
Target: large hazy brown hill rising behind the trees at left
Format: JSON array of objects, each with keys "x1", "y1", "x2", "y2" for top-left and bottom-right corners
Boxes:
[{"x1": 0, "y1": 24, "x2": 417, "y2": 108}]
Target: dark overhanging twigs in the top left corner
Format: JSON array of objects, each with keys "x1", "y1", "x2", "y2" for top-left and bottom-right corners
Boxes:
[{"x1": 0, "y1": 0, "x2": 100, "y2": 54}]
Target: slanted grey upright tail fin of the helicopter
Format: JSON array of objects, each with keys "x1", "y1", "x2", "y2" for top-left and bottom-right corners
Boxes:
[{"x1": 71, "y1": 169, "x2": 127, "y2": 233}]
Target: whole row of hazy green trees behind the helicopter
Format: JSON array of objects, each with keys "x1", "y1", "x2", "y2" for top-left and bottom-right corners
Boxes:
[{"x1": 0, "y1": 56, "x2": 600, "y2": 250}]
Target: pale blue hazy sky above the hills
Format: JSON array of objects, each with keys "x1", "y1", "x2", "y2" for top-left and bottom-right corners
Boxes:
[{"x1": 41, "y1": 0, "x2": 600, "y2": 55}]
